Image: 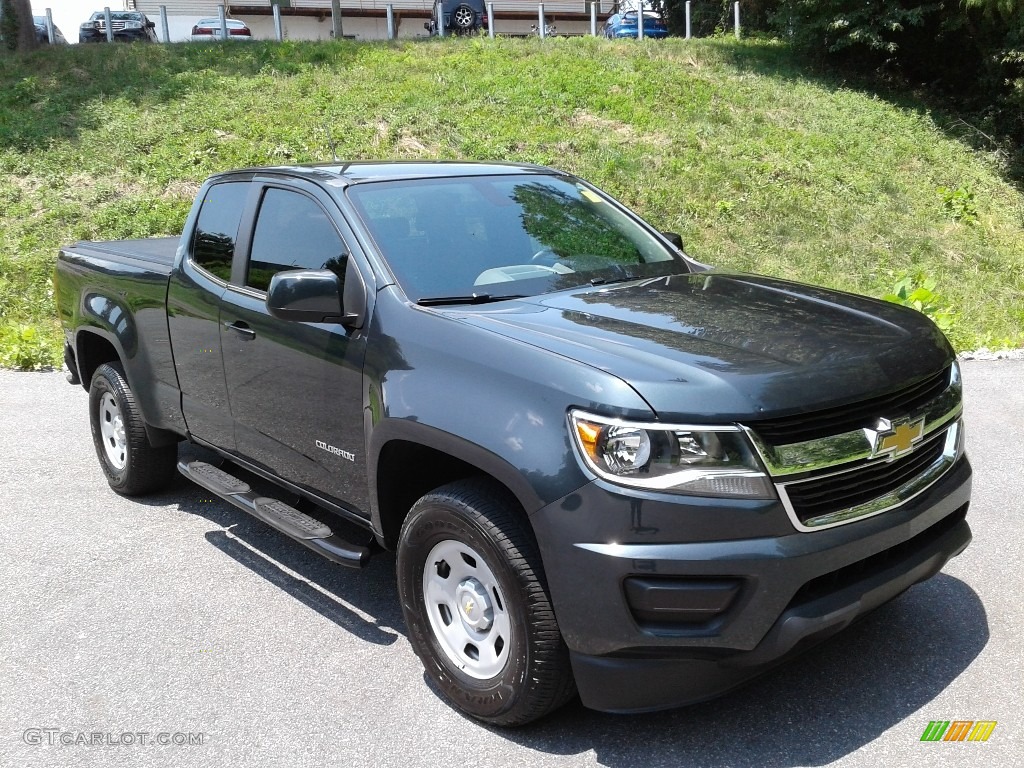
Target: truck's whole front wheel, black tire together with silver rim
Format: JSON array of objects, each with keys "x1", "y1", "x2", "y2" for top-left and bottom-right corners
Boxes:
[{"x1": 397, "y1": 479, "x2": 575, "y2": 726}]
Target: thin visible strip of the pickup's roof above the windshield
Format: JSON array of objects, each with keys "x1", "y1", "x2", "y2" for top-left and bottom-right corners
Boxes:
[{"x1": 207, "y1": 160, "x2": 562, "y2": 186}]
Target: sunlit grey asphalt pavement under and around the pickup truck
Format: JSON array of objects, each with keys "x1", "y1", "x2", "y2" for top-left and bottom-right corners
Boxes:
[{"x1": 0, "y1": 360, "x2": 1024, "y2": 768}]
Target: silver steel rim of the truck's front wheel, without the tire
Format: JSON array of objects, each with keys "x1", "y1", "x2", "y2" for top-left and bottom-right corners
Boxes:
[{"x1": 423, "y1": 539, "x2": 512, "y2": 680}]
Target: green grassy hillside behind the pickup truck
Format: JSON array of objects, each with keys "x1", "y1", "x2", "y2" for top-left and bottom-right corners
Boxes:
[{"x1": 0, "y1": 38, "x2": 1024, "y2": 367}]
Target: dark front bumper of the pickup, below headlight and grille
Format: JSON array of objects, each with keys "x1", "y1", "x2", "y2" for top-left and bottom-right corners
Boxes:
[{"x1": 532, "y1": 458, "x2": 971, "y2": 712}]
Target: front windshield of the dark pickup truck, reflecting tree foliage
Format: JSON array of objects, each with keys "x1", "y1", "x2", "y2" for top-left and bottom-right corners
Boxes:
[{"x1": 348, "y1": 175, "x2": 686, "y2": 301}]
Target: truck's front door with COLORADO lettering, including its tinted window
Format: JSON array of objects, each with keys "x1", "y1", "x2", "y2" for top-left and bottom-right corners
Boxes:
[{"x1": 220, "y1": 180, "x2": 370, "y2": 517}]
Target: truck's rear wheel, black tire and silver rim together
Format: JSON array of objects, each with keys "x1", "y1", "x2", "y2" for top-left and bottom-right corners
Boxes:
[{"x1": 89, "y1": 362, "x2": 178, "y2": 496}]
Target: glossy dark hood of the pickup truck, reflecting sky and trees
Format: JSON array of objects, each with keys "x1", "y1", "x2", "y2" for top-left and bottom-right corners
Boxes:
[{"x1": 452, "y1": 271, "x2": 953, "y2": 423}]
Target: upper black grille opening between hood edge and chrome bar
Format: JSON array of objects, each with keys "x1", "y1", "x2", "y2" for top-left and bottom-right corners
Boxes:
[{"x1": 748, "y1": 368, "x2": 950, "y2": 445}]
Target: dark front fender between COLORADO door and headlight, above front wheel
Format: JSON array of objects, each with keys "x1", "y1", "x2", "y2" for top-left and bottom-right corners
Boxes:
[{"x1": 365, "y1": 291, "x2": 653, "y2": 524}]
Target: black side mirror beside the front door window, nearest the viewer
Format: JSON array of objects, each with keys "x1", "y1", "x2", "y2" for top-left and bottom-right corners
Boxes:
[{"x1": 266, "y1": 259, "x2": 367, "y2": 328}]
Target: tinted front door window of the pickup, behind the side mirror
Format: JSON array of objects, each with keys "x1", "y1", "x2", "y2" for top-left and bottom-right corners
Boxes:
[{"x1": 246, "y1": 187, "x2": 348, "y2": 291}]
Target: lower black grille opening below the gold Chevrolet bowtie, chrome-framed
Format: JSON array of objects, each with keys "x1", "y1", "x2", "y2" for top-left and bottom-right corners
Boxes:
[{"x1": 785, "y1": 430, "x2": 946, "y2": 524}]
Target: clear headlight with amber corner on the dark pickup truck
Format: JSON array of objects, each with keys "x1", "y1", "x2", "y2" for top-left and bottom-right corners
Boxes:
[{"x1": 569, "y1": 411, "x2": 775, "y2": 499}]
